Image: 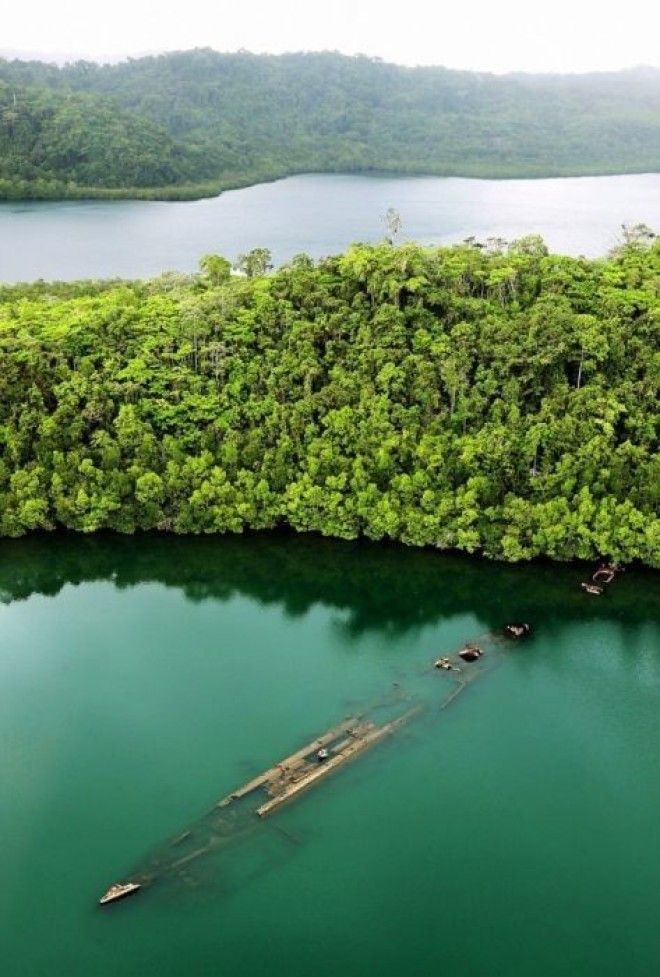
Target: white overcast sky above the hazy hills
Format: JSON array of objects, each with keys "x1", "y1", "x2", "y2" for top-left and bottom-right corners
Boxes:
[{"x1": 5, "y1": 0, "x2": 660, "y2": 72}]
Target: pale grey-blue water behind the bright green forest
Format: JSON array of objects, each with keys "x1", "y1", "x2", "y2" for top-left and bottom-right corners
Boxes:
[{"x1": 0, "y1": 174, "x2": 660, "y2": 282}]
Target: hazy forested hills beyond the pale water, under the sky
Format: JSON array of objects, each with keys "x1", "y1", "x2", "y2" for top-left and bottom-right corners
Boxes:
[{"x1": 0, "y1": 49, "x2": 660, "y2": 199}]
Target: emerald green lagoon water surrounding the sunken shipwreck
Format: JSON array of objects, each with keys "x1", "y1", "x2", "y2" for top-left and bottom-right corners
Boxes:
[{"x1": 0, "y1": 535, "x2": 660, "y2": 977}]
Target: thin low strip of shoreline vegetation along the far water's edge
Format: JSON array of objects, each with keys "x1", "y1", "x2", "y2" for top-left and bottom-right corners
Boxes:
[{"x1": 5, "y1": 166, "x2": 660, "y2": 203}]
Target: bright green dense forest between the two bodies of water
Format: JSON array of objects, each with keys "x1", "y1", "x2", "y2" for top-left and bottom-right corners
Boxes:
[{"x1": 0, "y1": 230, "x2": 660, "y2": 566}]
